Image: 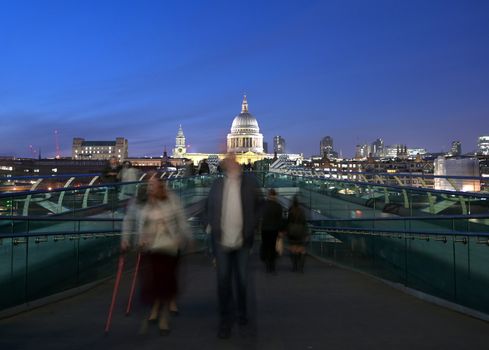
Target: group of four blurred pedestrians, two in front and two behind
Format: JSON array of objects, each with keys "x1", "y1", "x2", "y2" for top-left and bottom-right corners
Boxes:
[{"x1": 121, "y1": 154, "x2": 307, "y2": 338}]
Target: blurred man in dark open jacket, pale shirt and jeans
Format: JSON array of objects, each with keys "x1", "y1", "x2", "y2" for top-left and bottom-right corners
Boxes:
[{"x1": 206, "y1": 154, "x2": 261, "y2": 338}]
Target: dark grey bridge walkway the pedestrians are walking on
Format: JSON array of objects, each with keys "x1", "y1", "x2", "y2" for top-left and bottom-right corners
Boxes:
[{"x1": 0, "y1": 254, "x2": 489, "y2": 350}]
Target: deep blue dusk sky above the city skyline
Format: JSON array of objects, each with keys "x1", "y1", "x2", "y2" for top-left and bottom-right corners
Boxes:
[{"x1": 0, "y1": 0, "x2": 489, "y2": 157}]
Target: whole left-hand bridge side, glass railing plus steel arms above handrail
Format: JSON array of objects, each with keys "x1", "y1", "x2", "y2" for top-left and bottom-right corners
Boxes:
[{"x1": 0, "y1": 176, "x2": 214, "y2": 311}]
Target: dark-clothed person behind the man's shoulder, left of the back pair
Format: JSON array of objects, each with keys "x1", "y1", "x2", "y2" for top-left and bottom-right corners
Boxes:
[{"x1": 261, "y1": 188, "x2": 283, "y2": 273}]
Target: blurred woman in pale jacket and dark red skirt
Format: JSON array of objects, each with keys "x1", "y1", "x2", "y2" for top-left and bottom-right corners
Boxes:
[{"x1": 121, "y1": 177, "x2": 190, "y2": 335}]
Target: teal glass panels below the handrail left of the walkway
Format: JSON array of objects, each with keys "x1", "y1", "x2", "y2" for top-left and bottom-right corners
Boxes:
[{"x1": 0, "y1": 218, "x2": 206, "y2": 311}]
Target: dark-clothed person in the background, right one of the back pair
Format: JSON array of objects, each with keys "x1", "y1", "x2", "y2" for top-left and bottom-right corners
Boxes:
[{"x1": 287, "y1": 196, "x2": 308, "y2": 272}]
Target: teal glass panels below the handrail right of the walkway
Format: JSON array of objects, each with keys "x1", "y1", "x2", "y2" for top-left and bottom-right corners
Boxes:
[{"x1": 309, "y1": 215, "x2": 489, "y2": 314}]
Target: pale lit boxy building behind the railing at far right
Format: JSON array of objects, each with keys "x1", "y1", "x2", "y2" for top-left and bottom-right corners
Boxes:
[{"x1": 434, "y1": 157, "x2": 481, "y2": 192}]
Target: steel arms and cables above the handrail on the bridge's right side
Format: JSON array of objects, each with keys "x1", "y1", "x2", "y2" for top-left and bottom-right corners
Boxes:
[{"x1": 266, "y1": 173, "x2": 489, "y2": 218}]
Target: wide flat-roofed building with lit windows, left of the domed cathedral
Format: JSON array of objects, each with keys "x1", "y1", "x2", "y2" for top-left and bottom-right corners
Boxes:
[{"x1": 71, "y1": 137, "x2": 128, "y2": 161}]
